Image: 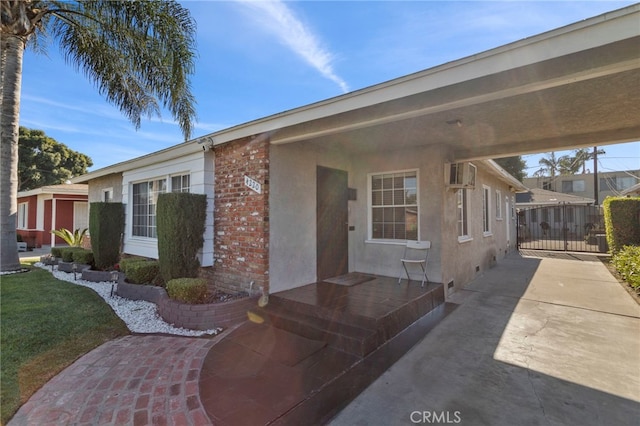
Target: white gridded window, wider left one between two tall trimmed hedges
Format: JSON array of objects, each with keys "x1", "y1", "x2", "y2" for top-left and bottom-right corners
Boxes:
[{"x1": 132, "y1": 179, "x2": 167, "y2": 238}]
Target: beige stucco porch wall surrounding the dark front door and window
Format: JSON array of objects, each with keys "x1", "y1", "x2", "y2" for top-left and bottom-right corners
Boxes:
[{"x1": 269, "y1": 143, "x2": 445, "y2": 292}]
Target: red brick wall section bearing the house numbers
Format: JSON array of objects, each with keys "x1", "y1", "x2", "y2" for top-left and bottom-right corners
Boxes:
[{"x1": 211, "y1": 138, "x2": 269, "y2": 291}]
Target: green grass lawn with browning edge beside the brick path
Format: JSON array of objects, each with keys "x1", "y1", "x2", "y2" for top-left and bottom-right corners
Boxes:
[{"x1": 0, "y1": 268, "x2": 129, "y2": 424}]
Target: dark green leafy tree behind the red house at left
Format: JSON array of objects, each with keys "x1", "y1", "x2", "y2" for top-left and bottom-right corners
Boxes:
[{"x1": 18, "y1": 127, "x2": 93, "y2": 191}]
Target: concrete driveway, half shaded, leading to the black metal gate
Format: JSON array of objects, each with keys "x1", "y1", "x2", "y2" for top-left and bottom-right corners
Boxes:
[{"x1": 330, "y1": 253, "x2": 640, "y2": 426}]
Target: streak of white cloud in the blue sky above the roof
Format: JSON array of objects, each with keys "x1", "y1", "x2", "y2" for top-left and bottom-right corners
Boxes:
[{"x1": 236, "y1": 0, "x2": 349, "y2": 93}]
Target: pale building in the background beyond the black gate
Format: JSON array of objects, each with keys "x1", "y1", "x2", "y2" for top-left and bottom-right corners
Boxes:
[{"x1": 524, "y1": 170, "x2": 640, "y2": 204}]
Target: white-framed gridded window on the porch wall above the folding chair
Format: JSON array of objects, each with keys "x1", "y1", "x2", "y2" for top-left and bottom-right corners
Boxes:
[{"x1": 369, "y1": 170, "x2": 419, "y2": 240}]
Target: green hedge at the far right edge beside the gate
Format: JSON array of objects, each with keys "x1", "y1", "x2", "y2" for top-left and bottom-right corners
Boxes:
[{"x1": 602, "y1": 197, "x2": 640, "y2": 254}]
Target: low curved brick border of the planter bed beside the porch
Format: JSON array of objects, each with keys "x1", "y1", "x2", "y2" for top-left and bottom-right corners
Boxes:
[{"x1": 116, "y1": 279, "x2": 259, "y2": 330}]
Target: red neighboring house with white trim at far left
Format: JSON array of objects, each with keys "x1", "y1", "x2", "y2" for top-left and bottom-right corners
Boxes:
[{"x1": 17, "y1": 184, "x2": 89, "y2": 248}]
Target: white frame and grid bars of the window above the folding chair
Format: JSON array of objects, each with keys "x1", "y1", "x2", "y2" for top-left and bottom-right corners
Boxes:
[{"x1": 367, "y1": 169, "x2": 420, "y2": 244}]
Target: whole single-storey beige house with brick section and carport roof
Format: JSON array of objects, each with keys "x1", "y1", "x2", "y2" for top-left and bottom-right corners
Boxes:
[{"x1": 74, "y1": 5, "x2": 640, "y2": 293}]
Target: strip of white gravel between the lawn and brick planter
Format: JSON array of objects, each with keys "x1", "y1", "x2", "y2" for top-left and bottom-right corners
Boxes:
[{"x1": 34, "y1": 262, "x2": 222, "y2": 336}]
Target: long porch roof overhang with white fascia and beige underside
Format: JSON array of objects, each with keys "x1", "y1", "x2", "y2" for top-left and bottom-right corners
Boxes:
[{"x1": 197, "y1": 4, "x2": 640, "y2": 161}]
